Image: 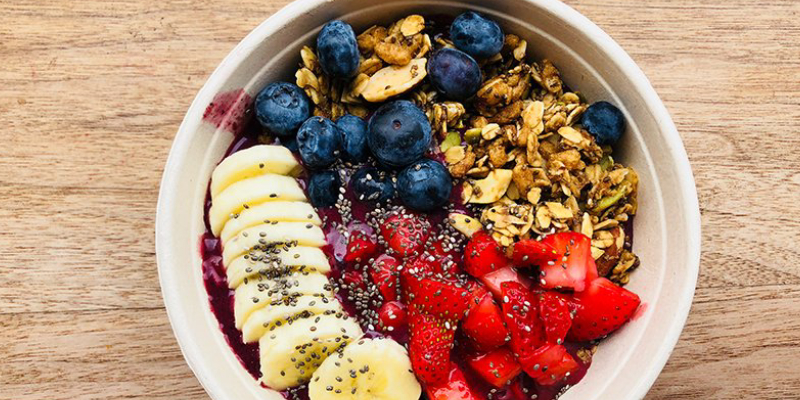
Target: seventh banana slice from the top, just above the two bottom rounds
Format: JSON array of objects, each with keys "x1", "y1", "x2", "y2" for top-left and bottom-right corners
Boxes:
[{"x1": 242, "y1": 296, "x2": 343, "y2": 343}]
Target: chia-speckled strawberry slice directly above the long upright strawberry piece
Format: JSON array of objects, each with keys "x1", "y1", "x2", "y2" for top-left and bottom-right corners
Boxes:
[{"x1": 406, "y1": 277, "x2": 469, "y2": 322}]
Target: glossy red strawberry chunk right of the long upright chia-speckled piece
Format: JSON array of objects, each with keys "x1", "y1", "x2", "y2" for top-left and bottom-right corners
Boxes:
[{"x1": 461, "y1": 296, "x2": 508, "y2": 351}]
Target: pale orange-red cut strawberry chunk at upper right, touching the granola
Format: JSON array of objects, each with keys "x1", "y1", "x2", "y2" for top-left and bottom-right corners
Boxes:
[{"x1": 539, "y1": 232, "x2": 597, "y2": 292}]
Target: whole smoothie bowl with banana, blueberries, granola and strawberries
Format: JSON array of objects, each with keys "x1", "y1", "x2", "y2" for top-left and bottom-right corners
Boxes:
[{"x1": 156, "y1": 0, "x2": 700, "y2": 400}]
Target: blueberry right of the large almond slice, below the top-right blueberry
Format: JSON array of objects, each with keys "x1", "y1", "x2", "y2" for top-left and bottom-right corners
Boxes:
[{"x1": 428, "y1": 48, "x2": 481, "y2": 100}]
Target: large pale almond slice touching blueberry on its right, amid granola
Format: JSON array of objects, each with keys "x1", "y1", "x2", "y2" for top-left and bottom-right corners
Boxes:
[{"x1": 361, "y1": 58, "x2": 428, "y2": 103}]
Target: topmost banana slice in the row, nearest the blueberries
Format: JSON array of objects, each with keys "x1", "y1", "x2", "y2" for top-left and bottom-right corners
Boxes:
[{"x1": 211, "y1": 145, "x2": 302, "y2": 198}]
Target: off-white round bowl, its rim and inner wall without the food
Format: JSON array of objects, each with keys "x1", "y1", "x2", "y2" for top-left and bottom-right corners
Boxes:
[{"x1": 156, "y1": 0, "x2": 700, "y2": 400}]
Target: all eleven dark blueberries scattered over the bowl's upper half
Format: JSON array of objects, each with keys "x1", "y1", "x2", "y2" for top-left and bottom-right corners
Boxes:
[{"x1": 250, "y1": 11, "x2": 625, "y2": 211}]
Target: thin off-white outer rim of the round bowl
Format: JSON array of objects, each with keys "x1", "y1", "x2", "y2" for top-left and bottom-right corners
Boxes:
[{"x1": 155, "y1": 0, "x2": 701, "y2": 398}]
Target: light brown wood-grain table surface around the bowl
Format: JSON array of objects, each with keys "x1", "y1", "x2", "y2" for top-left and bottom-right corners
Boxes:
[{"x1": 0, "y1": 0, "x2": 800, "y2": 400}]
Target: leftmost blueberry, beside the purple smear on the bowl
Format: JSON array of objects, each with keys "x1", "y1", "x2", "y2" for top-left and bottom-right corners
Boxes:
[{"x1": 256, "y1": 82, "x2": 311, "y2": 136}]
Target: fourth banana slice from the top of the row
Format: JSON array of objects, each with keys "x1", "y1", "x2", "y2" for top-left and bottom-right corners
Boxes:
[{"x1": 222, "y1": 222, "x2": 326, "y2": 265}]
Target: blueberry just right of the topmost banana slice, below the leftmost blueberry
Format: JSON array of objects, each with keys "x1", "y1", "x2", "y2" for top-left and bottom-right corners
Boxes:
[{"x1": 297, "y1": 117, "x2": 342, "y2": 168}]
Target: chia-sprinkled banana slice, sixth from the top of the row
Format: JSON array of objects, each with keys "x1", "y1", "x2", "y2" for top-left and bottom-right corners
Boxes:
[{"x1": 233, "y1": 271, "x2": 333, "y2": 330}]
